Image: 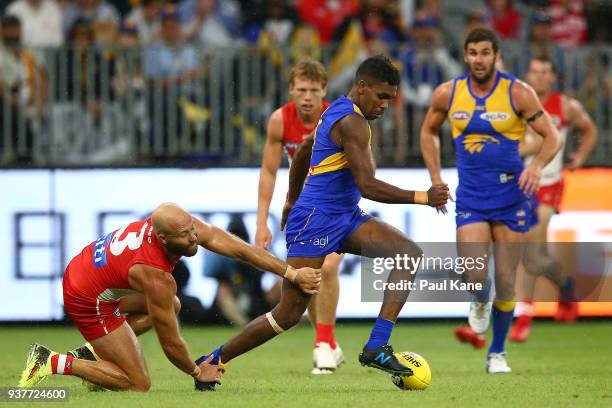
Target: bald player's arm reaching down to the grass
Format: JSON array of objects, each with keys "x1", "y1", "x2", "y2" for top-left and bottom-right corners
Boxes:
[{"x1": 128, "y1": 264, "x2": 223, "y2": 382}]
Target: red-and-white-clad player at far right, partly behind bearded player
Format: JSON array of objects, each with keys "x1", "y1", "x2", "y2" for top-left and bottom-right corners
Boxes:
[{"x1": 510, "y1": 57, "x2": 597, "y2": 341}]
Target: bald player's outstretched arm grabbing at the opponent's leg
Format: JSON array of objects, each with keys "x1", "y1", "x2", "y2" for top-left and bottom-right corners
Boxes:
[{"x1": 193, "y1": 217, "x2": 321, "y2": 294}]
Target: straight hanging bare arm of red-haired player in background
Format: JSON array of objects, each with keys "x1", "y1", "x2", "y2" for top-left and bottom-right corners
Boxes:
[{"x1": 255, "y1": 109, "x2": 283, "y2": 248}]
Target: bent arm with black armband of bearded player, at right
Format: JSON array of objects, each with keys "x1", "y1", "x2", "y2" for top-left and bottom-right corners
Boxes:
[{"x1": 511, "y1": 80, "x2": 561, "y2": 194}]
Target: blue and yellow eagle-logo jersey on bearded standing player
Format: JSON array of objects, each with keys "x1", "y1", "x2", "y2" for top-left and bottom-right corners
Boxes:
[{"x1": 448, "y1": 72, "x2": 526, "y2": 210}]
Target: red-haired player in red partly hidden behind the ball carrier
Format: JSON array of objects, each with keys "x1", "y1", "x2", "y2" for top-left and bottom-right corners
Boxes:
[{"x1": 255, "y1": 59, "x2": 344, "y2": 374}]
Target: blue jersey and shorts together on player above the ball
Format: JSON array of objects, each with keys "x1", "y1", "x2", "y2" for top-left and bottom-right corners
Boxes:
[{"x1": 285, "y1": 96, "x2": 371, "y2": 257}]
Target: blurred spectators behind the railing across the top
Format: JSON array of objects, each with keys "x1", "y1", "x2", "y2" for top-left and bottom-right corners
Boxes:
[{"x1": 0, "y1": 0, "x2": 612, "y2": 166}]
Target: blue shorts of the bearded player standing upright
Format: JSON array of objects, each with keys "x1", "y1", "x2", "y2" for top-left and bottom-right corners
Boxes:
[{"x1": 455, "y1": 196, "x2": 538, "y2": 232}]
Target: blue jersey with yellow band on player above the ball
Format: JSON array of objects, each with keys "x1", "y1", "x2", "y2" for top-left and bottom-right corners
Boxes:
[{"x1": 296, "y1": 96, "x2": 371, "y2": 211}]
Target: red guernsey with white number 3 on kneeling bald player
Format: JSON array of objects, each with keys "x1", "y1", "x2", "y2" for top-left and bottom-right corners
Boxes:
[{"x1": 64, "y1": 218, "x2": 178, "y2": 302}]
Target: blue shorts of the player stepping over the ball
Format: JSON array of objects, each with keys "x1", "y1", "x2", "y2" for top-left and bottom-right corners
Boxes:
[{"x1": 285, "y1": 206, "x2": 372, "y2": 258}]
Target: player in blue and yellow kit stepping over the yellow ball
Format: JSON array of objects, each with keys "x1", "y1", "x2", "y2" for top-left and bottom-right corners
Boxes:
[{"x1": 196, "y1": 56, "x2": 449, "y2": 388}]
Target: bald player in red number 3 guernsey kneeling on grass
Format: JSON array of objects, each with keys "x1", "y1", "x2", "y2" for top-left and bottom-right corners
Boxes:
[{"x1": 19, "y1": 203, "x2": 321, "y2": 391}]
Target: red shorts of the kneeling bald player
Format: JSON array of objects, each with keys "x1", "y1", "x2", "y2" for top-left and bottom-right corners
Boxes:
[{"x1": 64, "y1": 265, "x2": 125, "y2": 341}]
